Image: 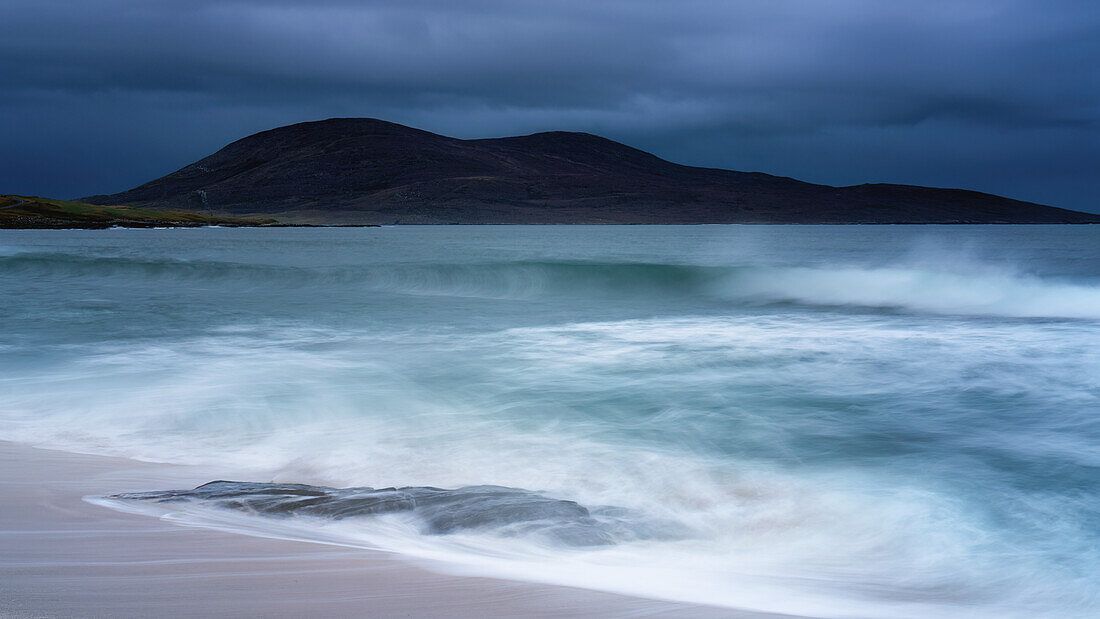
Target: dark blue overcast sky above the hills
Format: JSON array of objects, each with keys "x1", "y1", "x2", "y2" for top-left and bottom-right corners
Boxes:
[{"x1": 0, "y1": 0, "x2": 1100, "y2": 211}]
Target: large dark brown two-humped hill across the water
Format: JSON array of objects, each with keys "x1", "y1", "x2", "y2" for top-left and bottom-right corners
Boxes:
[{"x1": 85, "y1": 119, "x2": 1100, "y2": 223}]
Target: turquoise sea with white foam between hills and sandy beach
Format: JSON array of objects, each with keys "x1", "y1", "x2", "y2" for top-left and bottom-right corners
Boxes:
[{"x1": 0, "y1": 225, "x2": 1100, "y2": 617}]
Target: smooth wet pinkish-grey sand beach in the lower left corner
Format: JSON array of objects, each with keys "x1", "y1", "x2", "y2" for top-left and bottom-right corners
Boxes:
[{"x1": 0, "y1": 442, "x2": 774, "y2": 617}]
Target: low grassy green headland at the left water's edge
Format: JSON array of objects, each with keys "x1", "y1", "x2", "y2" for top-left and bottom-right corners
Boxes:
[{"x1": 0, "y1": 195, "x2": 275, "y2": 229}]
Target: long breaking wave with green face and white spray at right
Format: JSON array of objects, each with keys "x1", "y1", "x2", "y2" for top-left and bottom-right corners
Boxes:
[{"x1": 0, "y1": 253, "x2": 1100, "y2": 320}]
